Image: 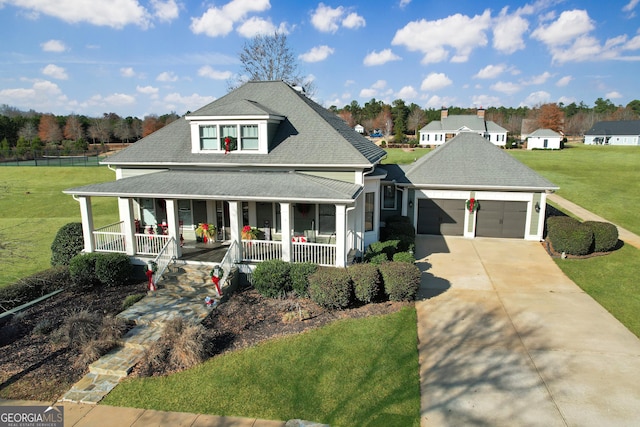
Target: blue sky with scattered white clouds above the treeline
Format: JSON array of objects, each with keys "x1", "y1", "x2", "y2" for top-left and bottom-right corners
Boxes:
[{"x1": 0, "y1": 0, "x2": 640, "y2": 118}]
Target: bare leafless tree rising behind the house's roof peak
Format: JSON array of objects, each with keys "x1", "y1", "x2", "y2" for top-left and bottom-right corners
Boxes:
[{"x1": 234, "y1": 31, "x2": 315, "y2": 95}]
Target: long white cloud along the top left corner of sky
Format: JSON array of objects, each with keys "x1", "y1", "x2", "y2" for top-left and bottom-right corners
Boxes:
[{"x1": 0, "y1": 0, "x2": 151, "y2": 28}]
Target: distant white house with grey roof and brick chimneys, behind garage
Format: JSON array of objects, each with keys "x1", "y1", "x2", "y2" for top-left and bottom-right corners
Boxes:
[{"x1": 418, "y1": 108, "x2": 507, "y2": 146}]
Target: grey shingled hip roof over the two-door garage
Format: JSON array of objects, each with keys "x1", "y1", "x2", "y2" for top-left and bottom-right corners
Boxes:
[{"x1": 406, "y1": 132, "x2": 558, "y2": 191}]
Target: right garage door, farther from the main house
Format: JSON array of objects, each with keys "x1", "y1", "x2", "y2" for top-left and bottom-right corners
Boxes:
[{"x1": 476, "y1": 200, "x2": 527, "y2": 239}]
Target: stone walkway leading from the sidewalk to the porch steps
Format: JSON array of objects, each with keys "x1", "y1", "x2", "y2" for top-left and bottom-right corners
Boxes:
[{"x1": 60, "y1": 263, "x2": 226, "y2": 404}]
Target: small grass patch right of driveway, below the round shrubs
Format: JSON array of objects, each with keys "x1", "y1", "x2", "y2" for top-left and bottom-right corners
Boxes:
[{"x1": 556, "y1": 245, "x2": 640, "y2": 337}]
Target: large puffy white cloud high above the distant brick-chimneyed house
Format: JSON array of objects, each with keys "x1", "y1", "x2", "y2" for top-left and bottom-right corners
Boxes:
[{"x1": 391, "y1": 10, "x2": 491, "y2": 64}]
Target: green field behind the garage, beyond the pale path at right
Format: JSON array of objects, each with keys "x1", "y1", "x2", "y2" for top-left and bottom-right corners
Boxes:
[{"x1": 508, "y1": 144, "x2": 640, "y2": 234}]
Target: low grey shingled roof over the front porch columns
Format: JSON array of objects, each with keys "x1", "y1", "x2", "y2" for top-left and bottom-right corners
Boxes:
[{"x1": 64, "y1": 170, "x2": 362, "y2": 204}]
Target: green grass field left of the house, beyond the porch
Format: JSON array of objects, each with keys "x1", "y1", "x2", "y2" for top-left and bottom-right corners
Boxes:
[{"x1": 0, "y1": 166, "x2": 118, "y2": 286}]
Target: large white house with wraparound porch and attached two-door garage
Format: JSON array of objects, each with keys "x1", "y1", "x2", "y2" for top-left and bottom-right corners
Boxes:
[{"x1": 65, "y1": 81, "x2": 556, "y2": 280}]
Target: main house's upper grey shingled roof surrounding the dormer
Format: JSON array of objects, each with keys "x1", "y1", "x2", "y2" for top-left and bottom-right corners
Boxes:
[{"x1": 103, "y1": 81, "x2": 386, "y2": 168}]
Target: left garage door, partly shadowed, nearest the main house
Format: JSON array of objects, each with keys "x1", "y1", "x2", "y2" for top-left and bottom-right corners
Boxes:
[{"x1": 417, "y1": 199, "x2": 464, "y2": 236}]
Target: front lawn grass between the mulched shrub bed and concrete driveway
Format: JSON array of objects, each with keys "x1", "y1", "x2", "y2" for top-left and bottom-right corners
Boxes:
[{"x1": 103, "y1": 308, "x2": 420, "y2": 427}]
